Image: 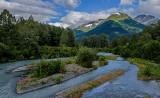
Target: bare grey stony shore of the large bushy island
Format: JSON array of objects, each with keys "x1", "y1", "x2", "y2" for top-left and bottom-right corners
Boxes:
[{"x1": 13, "y1": 62, "x2": 97, "y2": 94}]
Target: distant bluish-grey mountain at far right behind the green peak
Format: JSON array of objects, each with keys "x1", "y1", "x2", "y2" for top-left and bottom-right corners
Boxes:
[{"x1": 134, "y1": 15, "x2": 160, "y2": 25}]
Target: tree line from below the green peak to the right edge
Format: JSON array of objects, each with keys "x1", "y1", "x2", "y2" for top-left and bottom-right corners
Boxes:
[{"x1": 81, "y1": 21, "x2": 160, "y2": 63}]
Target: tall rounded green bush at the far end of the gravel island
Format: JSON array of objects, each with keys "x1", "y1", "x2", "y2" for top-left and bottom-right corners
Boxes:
[{"x1": 77, "y1": 47, "x2": 96, "y2": 68}]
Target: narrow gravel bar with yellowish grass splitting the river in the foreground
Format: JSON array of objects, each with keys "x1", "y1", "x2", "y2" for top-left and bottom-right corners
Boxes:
[{"x1": 55, "y1": 70, "x2": 125, "y2": 98}]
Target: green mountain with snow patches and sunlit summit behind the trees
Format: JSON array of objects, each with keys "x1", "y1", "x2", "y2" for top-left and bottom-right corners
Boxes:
[{"x1": 74, "y1": 13, "x2": 146, "y2": 41}]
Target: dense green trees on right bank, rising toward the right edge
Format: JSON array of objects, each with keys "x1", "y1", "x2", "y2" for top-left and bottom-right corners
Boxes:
[{"x1": 111, "y1": 21, "x2": 160, "y2": 63}]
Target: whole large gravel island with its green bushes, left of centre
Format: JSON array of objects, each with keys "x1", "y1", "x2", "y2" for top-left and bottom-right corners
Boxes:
[{"x1": 17, "y1": 47, "x2": 112, "y2": 94}]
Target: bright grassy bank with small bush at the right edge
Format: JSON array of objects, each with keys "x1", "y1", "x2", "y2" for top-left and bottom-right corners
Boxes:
[{"x1": 127, "y1": 58, "x2": 160, "y2": 80}]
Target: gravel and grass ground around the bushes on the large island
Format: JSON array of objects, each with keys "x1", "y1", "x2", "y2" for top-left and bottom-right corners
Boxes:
[{"x1": 15, "y1": 57, "x2": 107, "y2": 94}]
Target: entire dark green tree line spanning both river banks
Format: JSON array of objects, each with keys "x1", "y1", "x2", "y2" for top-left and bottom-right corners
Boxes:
[{"x1": 0, "y1": 9, "x2": 160, "y2": 62}]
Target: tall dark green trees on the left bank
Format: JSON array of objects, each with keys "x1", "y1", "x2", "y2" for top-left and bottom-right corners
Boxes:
[{"x1": 0, "y1": 9, "x2": 76, "y2": 62}]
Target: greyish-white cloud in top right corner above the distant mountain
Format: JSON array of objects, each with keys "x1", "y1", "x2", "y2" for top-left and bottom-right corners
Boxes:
[{"x1": 136, "y1": 0, "x2": 160, "y2": 17}]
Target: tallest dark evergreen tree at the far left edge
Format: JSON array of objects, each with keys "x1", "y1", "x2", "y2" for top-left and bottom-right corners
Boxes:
[{"x1": 0, "y1": 9, "x2": 17, "y2": 45}]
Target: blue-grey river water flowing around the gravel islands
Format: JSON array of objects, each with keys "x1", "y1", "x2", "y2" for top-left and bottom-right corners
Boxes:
[{"x1": 0, "y1": 53, "x2": 160, "y2": 98}]
